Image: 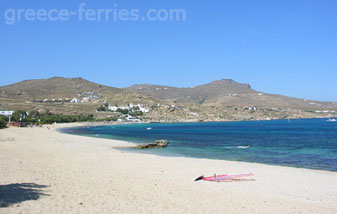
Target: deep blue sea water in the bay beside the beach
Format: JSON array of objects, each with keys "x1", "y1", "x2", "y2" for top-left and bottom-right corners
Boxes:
[{"x1": 62, "y1": 119, "x2": 337, "y2": 171}]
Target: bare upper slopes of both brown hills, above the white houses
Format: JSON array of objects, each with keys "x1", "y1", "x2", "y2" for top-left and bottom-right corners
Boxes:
[{"x1": 0, "y1": 76, "x2": 333, "y2": 108}]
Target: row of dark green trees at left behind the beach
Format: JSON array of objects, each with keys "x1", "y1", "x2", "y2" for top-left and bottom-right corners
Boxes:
[{"x1": 12, "y1": 110, "x2": 94, "y2": 124}]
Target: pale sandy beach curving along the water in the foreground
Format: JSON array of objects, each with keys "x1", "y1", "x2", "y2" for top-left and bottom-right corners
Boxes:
[{"x1": 0, "y1": 124, "x2": 337, "y2": 213}]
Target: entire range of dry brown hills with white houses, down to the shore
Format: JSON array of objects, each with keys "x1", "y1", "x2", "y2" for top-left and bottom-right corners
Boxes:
[{"x1": 0, "y1": 77, "x2": 337, "y2": 122}]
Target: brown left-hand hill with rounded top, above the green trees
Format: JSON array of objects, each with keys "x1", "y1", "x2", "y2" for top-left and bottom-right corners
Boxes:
[{"x1": 0, "y1": 77, "x2": 165, "y2": 117}]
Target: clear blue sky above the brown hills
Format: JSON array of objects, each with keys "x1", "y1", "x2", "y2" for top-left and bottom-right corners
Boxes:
[{"x1": 0, "y1": 0, "x2": 337, "y2": 101}]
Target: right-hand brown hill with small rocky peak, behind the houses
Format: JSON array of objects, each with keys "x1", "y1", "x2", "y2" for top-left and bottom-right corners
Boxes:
[{"x1": 125, "y1": 79, "x2": 336, "y2": 109}]
